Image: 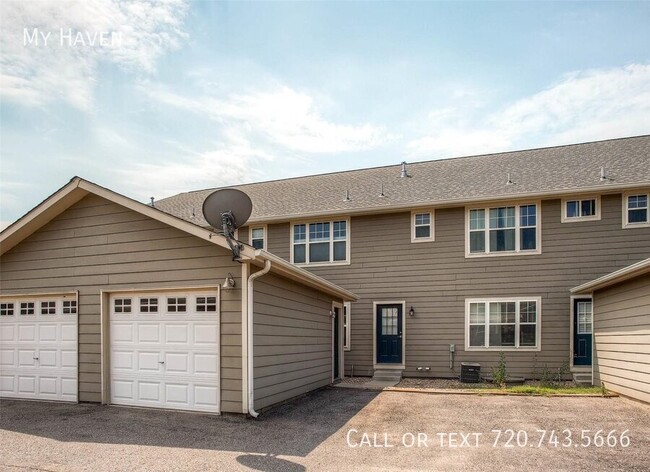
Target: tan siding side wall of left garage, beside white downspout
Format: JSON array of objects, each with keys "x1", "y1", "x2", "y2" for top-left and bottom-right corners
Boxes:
[{"x1": 253, "y1": 274, "x2": 332, "y2": 409}]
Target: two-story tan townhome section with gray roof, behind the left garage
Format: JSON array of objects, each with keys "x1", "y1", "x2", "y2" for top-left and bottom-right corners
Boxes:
[{"x1": 156, "y1": 136, "x2": 650, "y2": 388}]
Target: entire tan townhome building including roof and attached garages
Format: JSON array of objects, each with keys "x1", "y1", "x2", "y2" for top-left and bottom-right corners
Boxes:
[{"x1": 0, "y1": 136, "x2": 650, "y2": 410}]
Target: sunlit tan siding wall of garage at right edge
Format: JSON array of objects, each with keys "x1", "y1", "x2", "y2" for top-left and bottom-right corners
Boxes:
[{"x1": 594, "y1": 274, "x2": 650, "y2": 402}]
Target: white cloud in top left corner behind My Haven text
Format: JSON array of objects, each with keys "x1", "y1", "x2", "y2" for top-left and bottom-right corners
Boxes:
[{"x1": 0, "y1": 0, "x2": 187, "y2": 110}]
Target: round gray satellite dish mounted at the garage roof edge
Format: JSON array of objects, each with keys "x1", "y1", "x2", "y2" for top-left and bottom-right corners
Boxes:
[{"x1": 203, "y1": 188, "x2": 253, "y2": 261}]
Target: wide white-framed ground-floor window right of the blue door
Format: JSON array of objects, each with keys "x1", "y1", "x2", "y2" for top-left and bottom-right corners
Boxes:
[{"x1": 465, "y1": 298, "x2": 541, "y2": 350}]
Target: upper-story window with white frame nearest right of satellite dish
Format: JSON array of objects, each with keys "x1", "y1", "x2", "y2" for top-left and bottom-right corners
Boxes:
[{"x1": 291, "y1": 220, "x2": 350, "y2": 264}]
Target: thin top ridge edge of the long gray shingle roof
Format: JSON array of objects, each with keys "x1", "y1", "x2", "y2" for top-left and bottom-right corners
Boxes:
[{"x1": 158, "y1": 134, "x2": 650, "y2": 202}]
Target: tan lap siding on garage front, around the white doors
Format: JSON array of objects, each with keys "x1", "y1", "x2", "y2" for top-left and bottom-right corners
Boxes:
[{"x1": 0, "y1": 195, "x2": 242, "y2": 412}]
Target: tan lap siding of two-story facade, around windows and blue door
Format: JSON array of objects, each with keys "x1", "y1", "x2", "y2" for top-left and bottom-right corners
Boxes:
[{"x1": 268, "y1": 195, "x2": 650, "y2": 377}]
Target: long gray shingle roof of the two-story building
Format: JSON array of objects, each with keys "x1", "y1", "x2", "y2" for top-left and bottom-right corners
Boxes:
[{"x1": 155, "y1": 135, "x2": 650, "y2": 225}]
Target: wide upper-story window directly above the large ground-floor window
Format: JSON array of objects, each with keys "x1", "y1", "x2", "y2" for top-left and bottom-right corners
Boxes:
[{"x1": 466, "y1": 203, "x2": 541, "y2": 256}]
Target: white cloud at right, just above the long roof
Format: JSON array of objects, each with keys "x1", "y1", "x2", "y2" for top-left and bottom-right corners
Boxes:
[{"x1": 408, "y1": 64, "x2": 650, "y2": 157}]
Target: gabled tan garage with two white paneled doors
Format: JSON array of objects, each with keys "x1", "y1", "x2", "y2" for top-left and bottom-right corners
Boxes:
[{"x1": 0, "y1": 178, "x2": 356, "y2": 413}]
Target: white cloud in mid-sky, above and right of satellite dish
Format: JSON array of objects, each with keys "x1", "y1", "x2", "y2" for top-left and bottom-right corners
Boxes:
[{"x1": 141, "y1": 84, "x2": 395, "y2": 153}]
